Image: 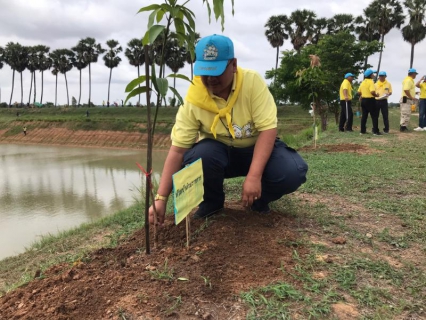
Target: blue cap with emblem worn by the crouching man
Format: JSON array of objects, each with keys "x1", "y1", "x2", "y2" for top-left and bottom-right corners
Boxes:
[{"x1": 194, "y1": 34, "x2": 234, "y2": 77}]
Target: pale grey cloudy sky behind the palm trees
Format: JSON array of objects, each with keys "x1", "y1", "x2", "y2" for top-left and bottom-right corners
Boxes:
[{"x1": 0, "y1": 0, "x2": 426, "y2": 105}]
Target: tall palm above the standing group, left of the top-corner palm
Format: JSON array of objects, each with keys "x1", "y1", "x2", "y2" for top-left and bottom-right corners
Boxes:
[{"x1": 364, "y1": 0, "x2": 404, "y2": 72}]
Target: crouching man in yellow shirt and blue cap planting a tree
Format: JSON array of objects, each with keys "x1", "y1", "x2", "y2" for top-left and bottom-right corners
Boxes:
[{"x1": 149, "y1": 35, "x2": 308, "y2": 225}]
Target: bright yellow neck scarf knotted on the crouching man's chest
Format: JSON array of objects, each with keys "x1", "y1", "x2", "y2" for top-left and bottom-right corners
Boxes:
[{"x1": 185, "y1": 67, "x2": 243, "y2": 139}]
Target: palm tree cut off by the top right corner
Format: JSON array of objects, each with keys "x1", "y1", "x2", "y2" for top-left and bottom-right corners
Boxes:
[{"x1": 401, "y1": 0, "x2": 426, "y2": 68}]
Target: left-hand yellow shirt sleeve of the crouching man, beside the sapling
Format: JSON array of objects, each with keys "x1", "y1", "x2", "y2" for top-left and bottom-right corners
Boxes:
[{"x1": 171, "y1": 101, "x2": 200, "y2": 148}]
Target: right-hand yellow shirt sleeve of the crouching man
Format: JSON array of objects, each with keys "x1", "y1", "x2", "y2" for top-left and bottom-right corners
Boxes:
[{"x1": 251, "y1": 72, "x2": 277, "y2": 131}]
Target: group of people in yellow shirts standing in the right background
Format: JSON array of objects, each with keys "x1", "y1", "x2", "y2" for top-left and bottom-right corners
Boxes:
[{"x1": 339, "y1": 69, "x2": 426, "y2": 135}]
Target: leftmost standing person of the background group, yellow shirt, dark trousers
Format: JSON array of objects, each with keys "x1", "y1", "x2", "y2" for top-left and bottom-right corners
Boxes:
[{"x1": 339, "y1": 73, "x2": 355, "y2": 132}]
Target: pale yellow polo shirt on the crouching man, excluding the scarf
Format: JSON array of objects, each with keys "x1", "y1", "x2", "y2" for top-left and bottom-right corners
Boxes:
[{"x1": 171, "y1": 69, "x2": 277, "y2": 148}]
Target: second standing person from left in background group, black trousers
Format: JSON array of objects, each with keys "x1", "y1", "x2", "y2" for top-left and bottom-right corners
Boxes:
[{"x1": 358, "y1": 69, "x2": 382, "y2": 136}]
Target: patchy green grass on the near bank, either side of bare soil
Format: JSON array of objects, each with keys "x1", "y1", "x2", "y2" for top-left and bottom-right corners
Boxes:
[{"x1": 0, "y1": 108, "x2": 426, "y2": 319}]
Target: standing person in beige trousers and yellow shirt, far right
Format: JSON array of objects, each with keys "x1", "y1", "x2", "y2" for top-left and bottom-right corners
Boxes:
[{"x1": 399, "y1": 68, "x2": 418, "y2": 132}]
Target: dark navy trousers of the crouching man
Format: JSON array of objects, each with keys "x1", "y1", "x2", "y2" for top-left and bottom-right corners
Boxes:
[{"x1": 183, "y1": 139, "x2": 308, "y2": 208}]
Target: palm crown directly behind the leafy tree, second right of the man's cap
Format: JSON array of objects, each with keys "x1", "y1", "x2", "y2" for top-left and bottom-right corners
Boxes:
[{"x1": 285, "y1": 9, "x2": 316, "y2": 53}]
